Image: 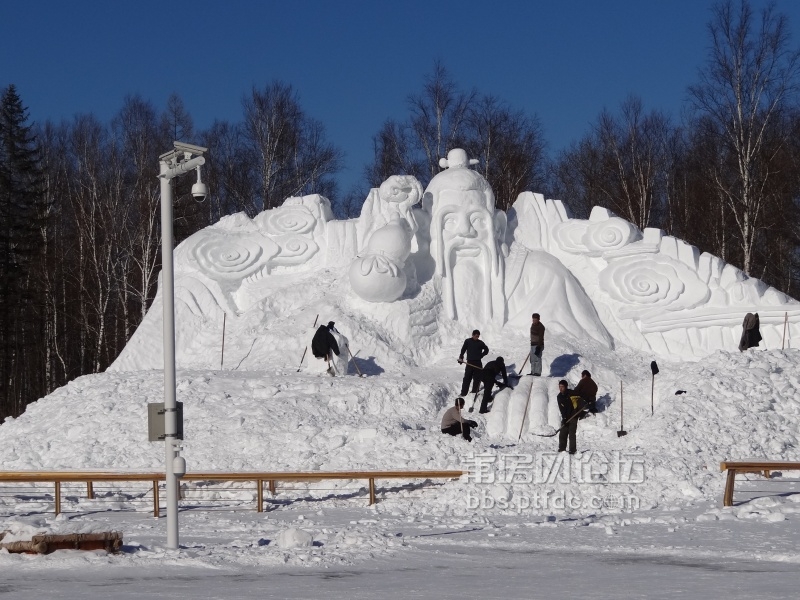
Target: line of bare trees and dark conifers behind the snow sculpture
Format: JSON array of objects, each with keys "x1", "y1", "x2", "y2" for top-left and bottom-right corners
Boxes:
[{"x1": 0, "y1": 1, "x2": 800, "y2": 419}]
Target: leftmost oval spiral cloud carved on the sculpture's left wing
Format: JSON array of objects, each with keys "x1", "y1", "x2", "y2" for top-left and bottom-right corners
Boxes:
[{"x1": 192, "y1": 232, "x2": 278, "y2": 279}]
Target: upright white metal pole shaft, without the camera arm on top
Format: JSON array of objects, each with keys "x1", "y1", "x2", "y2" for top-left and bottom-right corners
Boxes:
[{"x1": 161, "y1": 161, "x2": 178, "y2": 549}]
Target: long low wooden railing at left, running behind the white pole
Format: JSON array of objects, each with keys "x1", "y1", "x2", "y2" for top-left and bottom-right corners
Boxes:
[{"x1": 0, "y1": 471, "x2": 466, "y2": 517}]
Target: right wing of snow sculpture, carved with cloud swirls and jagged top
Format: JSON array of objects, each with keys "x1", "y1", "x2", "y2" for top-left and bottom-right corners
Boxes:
[{"x1": 512, "y1": 199, "x2": 800, "y2": 357}]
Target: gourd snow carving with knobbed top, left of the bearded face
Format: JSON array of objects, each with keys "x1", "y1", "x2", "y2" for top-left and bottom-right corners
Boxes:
[{"x1": 349, "y1": 175, "x2": 422, "y2": 302}]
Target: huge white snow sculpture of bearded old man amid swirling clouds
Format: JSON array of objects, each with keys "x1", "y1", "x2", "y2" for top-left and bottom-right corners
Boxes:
[{"x1": 112, "y1": 148, "x2": 800, "y2": 370}]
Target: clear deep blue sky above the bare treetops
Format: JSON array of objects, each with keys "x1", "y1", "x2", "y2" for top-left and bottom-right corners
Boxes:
[{"x1": 0, "y1": 0, "x2": 800, "y2": 192}]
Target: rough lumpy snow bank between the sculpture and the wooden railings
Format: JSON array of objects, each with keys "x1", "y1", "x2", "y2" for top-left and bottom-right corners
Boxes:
[{"x1": 0, "y1": 330, "x2": 800, "y2": 516}]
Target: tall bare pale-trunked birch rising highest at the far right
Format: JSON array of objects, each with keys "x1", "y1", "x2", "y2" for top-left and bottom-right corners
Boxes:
[{"x1": 689, "y1": 0, "x2": 800, "y2": 273}]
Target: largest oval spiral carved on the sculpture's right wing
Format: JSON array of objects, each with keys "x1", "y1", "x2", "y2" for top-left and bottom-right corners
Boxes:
[{"x1": 599, "y1": 255, "x2": 710, "y2": 316}]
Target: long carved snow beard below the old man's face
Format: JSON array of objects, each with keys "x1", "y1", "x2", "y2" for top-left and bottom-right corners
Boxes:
[{"x1": 442, "y1": 243, "x2": 493, "y2": 326}]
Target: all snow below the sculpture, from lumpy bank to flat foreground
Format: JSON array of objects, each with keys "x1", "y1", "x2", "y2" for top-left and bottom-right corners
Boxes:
[{"x1": 0, "y1": 340, "x2": 800, "y2": 598}]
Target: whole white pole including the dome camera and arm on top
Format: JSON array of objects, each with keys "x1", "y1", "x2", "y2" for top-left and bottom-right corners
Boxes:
[{"x1": 159, "y1": 142, "x2": 208, "y2": 549}]
